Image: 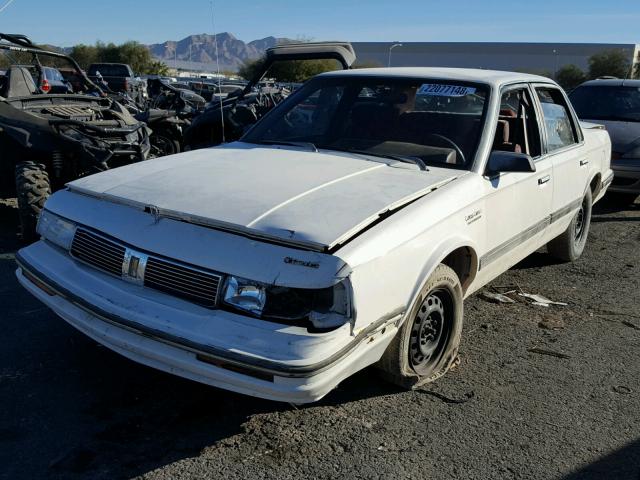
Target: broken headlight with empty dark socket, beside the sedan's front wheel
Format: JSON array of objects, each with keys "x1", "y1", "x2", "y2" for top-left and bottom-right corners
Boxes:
[{"x1": 224, "y1": 277, "x2": 351, "y2": 329}]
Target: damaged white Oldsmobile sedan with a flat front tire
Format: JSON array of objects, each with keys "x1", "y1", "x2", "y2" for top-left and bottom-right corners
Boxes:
[{"x1": 17, "y1": 68, "x2": 612, "y2": 403}]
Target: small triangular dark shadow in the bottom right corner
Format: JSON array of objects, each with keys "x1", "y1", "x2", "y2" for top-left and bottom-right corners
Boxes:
[{"x1": 563, "y1": 439, "x2": 640, "y2": 480}]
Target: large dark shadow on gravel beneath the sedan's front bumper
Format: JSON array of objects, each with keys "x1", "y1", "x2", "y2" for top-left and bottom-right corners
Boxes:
[{"x1": 0, "y1": 318, "x2": 399, "y2": 480}]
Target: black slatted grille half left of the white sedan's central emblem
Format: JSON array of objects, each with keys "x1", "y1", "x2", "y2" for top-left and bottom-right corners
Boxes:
[{"x1": 71, "y1": 228, "x2": 126, "y2": 276}]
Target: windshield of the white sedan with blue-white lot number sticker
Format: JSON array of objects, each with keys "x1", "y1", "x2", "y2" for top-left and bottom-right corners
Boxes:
[{"x1": 242, "y1": 76, "x2": 488, "y2": 169}]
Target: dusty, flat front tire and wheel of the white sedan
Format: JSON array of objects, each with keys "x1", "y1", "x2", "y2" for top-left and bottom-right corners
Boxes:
[{"x1": 377, "y1": 264, "x2": 463, "y2": 388}]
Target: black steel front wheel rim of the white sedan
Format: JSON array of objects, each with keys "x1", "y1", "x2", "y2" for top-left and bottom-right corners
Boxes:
[{"x1": 409, "y1": 289, "x2": 453, "y2": 374}]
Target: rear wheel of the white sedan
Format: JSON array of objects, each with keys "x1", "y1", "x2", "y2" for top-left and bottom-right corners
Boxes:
[{"x1": 547, "y1": 189, "x2": 593, "y2": 262}]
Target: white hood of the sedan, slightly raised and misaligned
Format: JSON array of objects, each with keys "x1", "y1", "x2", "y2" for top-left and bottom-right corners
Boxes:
[{"x1": 68, "y1": 142, "x2": 461, "y2": 251}]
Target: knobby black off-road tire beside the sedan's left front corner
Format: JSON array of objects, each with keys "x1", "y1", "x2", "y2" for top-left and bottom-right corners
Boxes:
[{"x1": 15, "y1": 162, "x2": 51, "y2": 243}]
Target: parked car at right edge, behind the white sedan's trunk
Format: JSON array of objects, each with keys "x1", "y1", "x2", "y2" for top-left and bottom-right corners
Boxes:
[{"x1": 569, "y1": 79, "x2": 640, "y2": 204}]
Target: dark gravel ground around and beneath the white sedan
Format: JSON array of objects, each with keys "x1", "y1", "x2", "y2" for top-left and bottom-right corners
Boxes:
[{"x1": 0, "y1": 196, "x2": 640, "y2": 480}]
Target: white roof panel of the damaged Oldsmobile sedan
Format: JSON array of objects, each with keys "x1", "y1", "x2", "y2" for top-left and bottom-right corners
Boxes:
[{"x1": 322, "y1": 67, "x2": 556, "y2": 88}]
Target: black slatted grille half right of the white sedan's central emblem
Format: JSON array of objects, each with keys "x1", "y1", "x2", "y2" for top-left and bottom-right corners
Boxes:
[{"x1": 144, "y1": 256, "x2": 221, "y2": 308}]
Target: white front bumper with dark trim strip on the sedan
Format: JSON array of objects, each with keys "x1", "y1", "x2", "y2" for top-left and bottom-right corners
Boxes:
[{"x1": 16, "y1": 242, "x2": 400, "y2": 403}]
